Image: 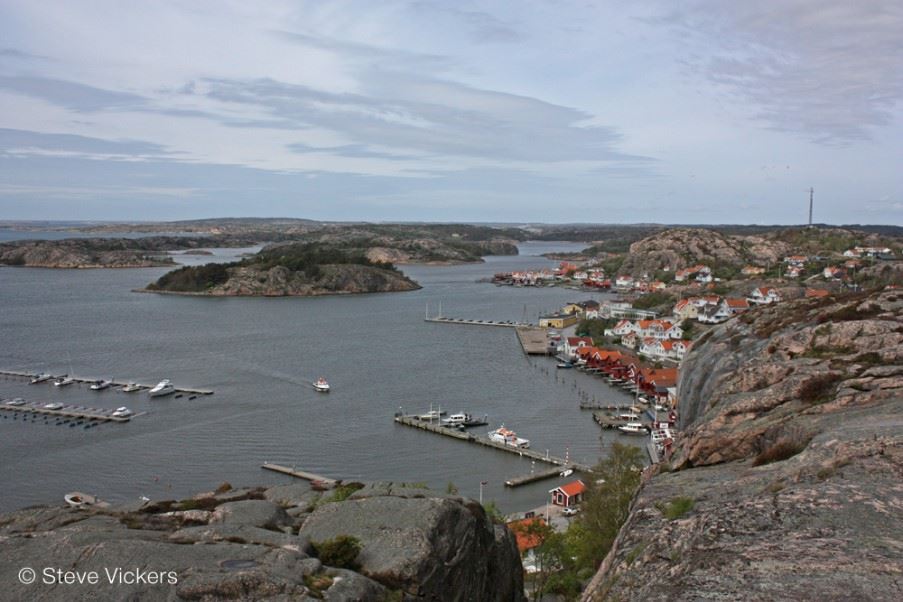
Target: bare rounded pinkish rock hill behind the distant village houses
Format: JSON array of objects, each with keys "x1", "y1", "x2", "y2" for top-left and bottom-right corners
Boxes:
[{"x1": 621, "y1": 228, "x2": 747, "y2": 276}]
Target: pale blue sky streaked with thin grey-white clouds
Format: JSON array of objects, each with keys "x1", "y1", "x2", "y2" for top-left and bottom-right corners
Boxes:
[{"x1": 0, "y1": 0, "x2": 903, "y2": 225}]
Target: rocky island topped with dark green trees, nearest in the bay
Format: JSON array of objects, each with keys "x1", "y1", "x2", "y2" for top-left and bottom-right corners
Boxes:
[{"x1": 145, "y1": 243, "x2": 420, "y2": 297}]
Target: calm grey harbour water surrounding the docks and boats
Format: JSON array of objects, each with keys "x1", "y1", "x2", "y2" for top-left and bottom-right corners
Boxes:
[{"x1": 0, "y1": 243, "x2": 629, "y2": 511}]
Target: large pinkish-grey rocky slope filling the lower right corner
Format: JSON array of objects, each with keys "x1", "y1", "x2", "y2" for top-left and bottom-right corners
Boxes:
[{"x1": 585, "y1": 291, "x2": 903, "y2": 601}]
